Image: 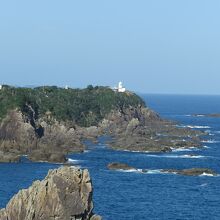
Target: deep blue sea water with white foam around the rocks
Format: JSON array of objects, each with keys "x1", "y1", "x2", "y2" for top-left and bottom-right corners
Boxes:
[{"x1": 0, "y1": 95, "x2": 220, "y2": 220}]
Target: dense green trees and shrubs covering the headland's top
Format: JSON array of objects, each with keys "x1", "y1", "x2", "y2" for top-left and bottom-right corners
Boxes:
[{"x1": 0, "y1": 85, "x2": 145, "y2": 127}]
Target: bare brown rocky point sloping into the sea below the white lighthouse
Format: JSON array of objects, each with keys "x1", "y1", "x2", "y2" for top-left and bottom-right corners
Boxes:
[{"x1": 100, "y1": 106, "x2": 204, "y2": 152}]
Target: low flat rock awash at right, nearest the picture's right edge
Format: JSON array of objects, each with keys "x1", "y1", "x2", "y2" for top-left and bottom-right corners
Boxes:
[{"x1": 161, "y1": 168, "x2": 217, "y2": 176}]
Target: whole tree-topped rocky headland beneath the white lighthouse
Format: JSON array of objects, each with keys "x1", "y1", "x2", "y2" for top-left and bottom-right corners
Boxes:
[{"x1": 0, "y1": 86, "x2": 205, "y2": 163}]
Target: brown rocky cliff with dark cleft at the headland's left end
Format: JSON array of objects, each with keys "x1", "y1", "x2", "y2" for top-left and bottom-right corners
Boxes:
[{"x1": 0, "y1": 110, "x2": 85, "y2": 163}]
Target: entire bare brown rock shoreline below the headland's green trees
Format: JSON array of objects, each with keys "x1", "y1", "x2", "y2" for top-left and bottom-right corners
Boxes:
[{"x1": 0, "y1": 107, "x2": 205, "y2": 163}]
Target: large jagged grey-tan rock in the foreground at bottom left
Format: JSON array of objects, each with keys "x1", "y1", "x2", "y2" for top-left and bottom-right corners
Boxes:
[{"x1": 0, "y1": 166, "x2": 101, "y2": 220}]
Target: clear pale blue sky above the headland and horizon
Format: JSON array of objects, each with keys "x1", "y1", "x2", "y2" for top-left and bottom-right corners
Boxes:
[{"x1": 0, "y1": 0, "x2": 220, "y2": 94}]
